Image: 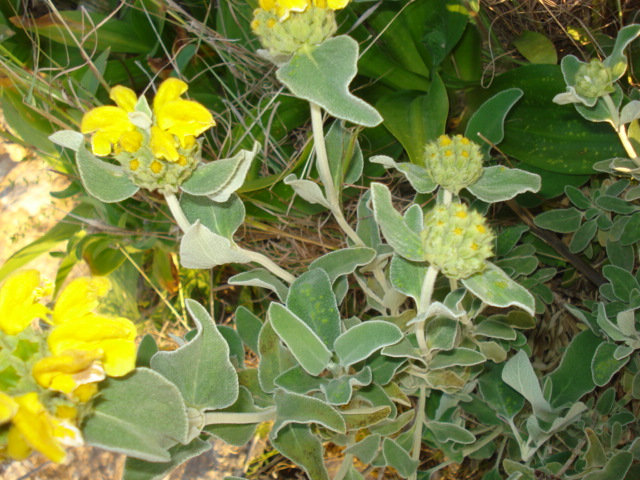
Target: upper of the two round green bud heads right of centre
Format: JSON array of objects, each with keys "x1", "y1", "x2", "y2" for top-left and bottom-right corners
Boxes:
[{"x1": 424, "y1": 135, "x2": 482, "y2": 194}]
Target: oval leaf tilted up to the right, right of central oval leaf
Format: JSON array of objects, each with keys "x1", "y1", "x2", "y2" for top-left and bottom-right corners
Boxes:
[{"x1": 334, "y1": 320, "x2": 403, "y2": 367}]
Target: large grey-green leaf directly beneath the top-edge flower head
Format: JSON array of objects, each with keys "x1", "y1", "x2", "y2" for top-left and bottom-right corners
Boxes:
[{"x1": 276, "y1": 36, "x2": 382, "y2": 127}]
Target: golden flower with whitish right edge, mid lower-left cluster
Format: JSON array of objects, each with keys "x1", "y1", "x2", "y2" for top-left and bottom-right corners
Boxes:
[{"x1": 31, "y1": 350, "x2": 105, "y2": 397}]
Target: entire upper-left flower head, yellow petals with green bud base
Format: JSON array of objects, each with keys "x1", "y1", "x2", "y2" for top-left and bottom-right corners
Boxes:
[{"x1": 80, "y1": 78, "x2": 216, "y2": 191}]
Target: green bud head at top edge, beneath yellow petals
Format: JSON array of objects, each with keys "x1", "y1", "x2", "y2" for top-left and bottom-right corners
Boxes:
[{"x1": 251, "y1": 7, "x2": 338, "y2": 56}]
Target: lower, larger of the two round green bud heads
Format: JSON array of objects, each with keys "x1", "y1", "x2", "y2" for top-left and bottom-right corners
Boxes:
[{"x1": 422, "y1": 203, "x2": 495, "y2": 279}]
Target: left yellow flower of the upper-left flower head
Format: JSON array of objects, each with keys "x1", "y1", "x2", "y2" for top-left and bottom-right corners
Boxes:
[{"x1": 80, "y1": 85, "x2": 142, "y2": 156}]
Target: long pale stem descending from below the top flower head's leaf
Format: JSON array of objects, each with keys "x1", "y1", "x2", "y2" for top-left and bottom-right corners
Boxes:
[{"x1": 309, "y1": 102, "x2": 365, "y2": 247}]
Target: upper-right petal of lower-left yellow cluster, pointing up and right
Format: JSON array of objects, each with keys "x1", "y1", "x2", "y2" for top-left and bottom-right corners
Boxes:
[{"x1": 53, "y1": 277, "x2": 111, "y2": 324}]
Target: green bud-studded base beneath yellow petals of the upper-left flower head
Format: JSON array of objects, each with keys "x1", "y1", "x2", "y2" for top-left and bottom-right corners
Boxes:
[{"x1": 115, "y1": 141, "x2": 202, "y2": 193}]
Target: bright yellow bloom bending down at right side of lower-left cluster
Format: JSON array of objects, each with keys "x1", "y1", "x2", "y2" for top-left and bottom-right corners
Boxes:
[{"x1": 47, "y1": 313, "x2": 136, "y2": 377}]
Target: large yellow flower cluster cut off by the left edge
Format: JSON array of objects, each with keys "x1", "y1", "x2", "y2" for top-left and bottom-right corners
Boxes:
[{"x1": 0, "y1": 270, "x2": 136, "y2": 462}]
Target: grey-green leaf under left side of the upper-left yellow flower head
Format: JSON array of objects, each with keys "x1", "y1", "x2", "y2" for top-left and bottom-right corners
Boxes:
[{"x1": 76, "y1": 146, "x2": 139, "y2": 203}]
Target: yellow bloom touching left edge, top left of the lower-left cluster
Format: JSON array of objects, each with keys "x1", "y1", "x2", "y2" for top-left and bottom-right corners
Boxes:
[{"x1": 0, "y1": 270, "x2": 49, "y2": 335}]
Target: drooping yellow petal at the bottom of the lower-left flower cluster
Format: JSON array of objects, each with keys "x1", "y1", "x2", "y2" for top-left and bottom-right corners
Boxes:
[{"x1": 8, "y1": 392, "x2": 66, "y2": 463}]
